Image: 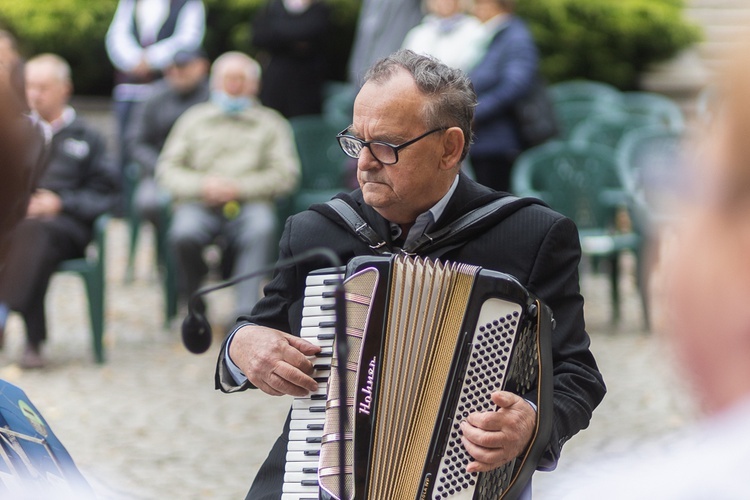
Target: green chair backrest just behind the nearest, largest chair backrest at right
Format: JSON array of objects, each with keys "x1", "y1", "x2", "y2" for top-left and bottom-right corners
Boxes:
[{"x1": 569, "y1": 113, "x2": 666, "y2": 149}]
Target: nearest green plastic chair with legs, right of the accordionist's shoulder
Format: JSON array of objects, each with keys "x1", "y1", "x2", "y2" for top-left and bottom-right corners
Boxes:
[{"x1": 511, "y1": 141, "x2": 641, "y2": 322}]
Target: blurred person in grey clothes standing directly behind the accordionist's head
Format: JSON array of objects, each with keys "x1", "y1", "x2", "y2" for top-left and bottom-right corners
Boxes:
[{"x1": 349, "y1": 0, "x2": 423, "y2": 88}]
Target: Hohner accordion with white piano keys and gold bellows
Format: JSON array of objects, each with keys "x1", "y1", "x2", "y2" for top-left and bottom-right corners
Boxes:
[{"x1": 282, "y1": 256, "x2": 553, "y2": 500}]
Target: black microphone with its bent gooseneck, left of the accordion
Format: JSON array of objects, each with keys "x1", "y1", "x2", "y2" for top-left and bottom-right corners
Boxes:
[{"x1": 182, "y1": 248, "x2": 346, "y2": 354}]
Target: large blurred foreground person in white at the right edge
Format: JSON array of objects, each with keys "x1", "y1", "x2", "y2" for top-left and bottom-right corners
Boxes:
[{"x1": 556, "y1": 33, "x2": 750, "y2": 500}]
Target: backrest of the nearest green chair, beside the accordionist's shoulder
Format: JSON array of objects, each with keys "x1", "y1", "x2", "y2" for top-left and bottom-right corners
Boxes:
[{"x1": 511, "y1": 141, "x2": 622, "y2": 230}]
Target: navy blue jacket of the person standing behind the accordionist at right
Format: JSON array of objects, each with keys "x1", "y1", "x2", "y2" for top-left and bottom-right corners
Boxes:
[{"x1": 469, "y1": 16, "x2": 539, "y2": 158}]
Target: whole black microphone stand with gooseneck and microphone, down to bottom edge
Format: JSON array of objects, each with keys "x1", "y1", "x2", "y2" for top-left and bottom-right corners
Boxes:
[{"x1": 182, "y1": 248, "x2": 354, "y2": 498}]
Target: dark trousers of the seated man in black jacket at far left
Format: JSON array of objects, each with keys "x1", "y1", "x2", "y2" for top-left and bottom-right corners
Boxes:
[{"x1": 0, "y1": 215, "x2": 91, "y2": 346}]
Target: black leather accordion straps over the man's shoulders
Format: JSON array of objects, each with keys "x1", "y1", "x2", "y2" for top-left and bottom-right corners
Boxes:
[{"x1": 326, "y1": 195, "x2": 541, "y2": 258}]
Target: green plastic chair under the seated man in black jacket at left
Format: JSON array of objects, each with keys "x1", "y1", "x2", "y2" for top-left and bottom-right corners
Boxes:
[{"x1": 57, "y1": 214, "x2": 110, "y2": 364}]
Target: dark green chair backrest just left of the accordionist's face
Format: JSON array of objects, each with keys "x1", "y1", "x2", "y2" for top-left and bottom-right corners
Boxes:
[{"x1": 289, "y1": 115, "x2": 347, "y2": 189}]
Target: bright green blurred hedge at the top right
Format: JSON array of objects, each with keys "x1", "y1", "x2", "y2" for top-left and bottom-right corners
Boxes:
[{"x1": 518, "y1": 0, "x2": 701, "y2": 90}]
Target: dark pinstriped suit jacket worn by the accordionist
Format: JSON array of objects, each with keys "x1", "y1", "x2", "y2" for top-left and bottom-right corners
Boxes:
[{"x1": 216, "y1": 175, "x2": 606, "y2": 499}]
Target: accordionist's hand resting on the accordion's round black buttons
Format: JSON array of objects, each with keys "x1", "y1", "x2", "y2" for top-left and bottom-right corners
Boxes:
[{"x1": 461, "y1": 391, "x2": 536, "y2": 472}]
